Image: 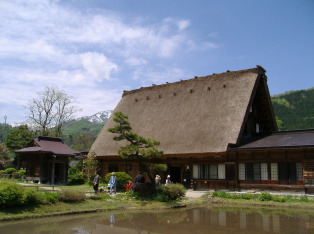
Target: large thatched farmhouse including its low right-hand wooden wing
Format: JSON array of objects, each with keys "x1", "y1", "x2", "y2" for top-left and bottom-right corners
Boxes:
[{"x1": 90, "y1": 66, "x2": 314, "y2": 190}]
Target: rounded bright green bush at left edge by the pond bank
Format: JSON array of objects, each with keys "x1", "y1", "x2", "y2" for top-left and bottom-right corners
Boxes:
[{"x1": 0, "y1": 182, "x2": 24, "y2": 207}]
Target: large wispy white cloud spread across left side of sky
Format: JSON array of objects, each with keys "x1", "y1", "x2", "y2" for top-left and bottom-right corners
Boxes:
[{"x1": 0, "y1": 0, "x2": 214, "y2": 124}]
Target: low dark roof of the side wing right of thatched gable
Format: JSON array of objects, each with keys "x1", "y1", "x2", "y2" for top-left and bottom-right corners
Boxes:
[{"x1": 234, "y1": 129, "x2": 314, "y2": 150}]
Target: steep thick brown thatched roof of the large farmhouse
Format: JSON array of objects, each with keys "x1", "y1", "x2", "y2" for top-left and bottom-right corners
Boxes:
[{"x1": 91, "y1": 67, "x2": 268, "y2": 156}]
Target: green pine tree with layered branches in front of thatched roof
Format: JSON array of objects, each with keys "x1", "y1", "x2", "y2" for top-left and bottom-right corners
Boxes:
[{"x1": 108, "y1": 112, "x2": 164, "y2": 182}]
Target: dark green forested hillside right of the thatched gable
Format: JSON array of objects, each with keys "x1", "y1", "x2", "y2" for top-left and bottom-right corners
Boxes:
[{"x1": 271, "y1": 88, "x2": 314, "y2": 130}]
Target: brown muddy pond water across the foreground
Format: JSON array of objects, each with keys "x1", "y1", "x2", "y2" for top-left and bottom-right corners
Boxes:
[{"x1": 0, "y1": 208, "x2": 314, "y2": 234}]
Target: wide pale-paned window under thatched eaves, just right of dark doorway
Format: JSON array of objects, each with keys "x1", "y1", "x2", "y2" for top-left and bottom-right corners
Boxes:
[{"x1": 193, "y1": 164, "x2": 226, "y2": 180}]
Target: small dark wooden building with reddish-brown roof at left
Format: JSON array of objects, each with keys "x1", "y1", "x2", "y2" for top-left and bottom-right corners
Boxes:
[{"x1": 15, "y1": 136, "x2": 79, "y2": 184}]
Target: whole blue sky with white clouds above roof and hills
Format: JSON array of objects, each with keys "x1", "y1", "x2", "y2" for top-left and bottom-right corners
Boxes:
[{"x1": 0, "y1": 0, "x2": 314, "y2": 124}]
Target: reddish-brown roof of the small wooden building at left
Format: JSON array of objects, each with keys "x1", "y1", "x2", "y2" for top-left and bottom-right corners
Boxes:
[{"x1": 15, "y1": 136, "x2": 79, "y2": 156}]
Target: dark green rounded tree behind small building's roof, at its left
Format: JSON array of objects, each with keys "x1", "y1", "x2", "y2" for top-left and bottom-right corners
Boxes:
[{"x1": 5, "y1": 125, "x2": 34, "y2": 152}]
